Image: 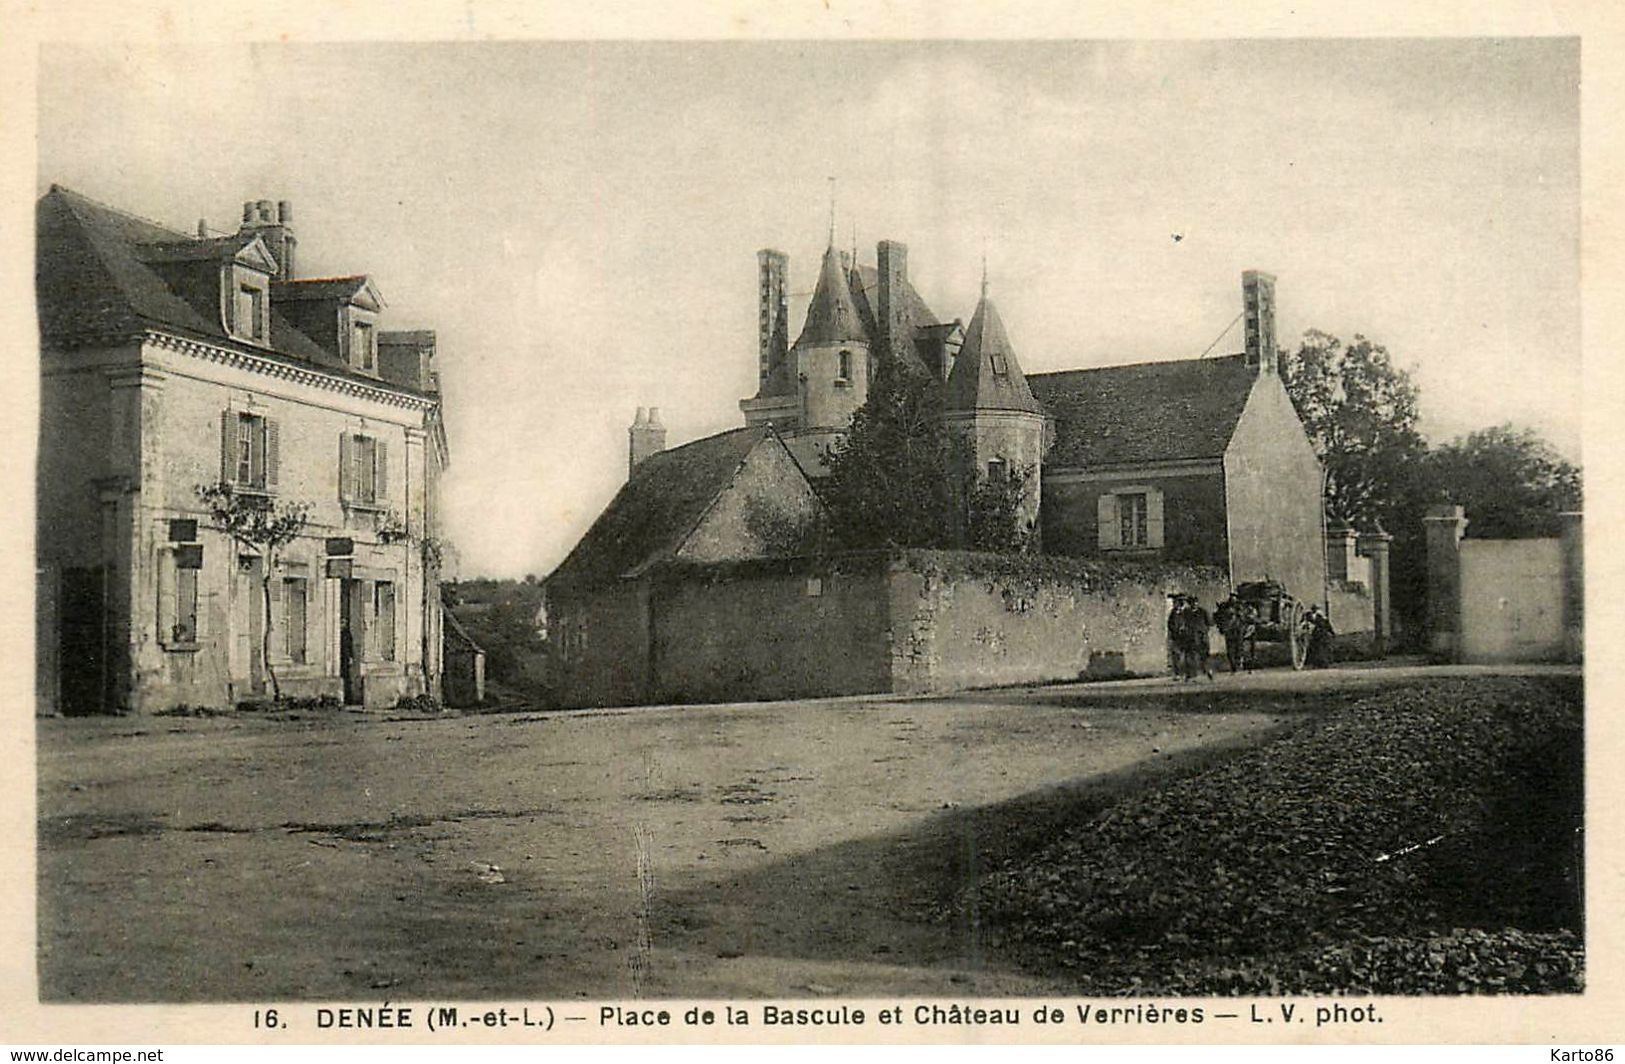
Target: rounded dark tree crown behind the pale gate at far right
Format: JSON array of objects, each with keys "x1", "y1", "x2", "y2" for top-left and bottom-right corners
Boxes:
[{"x1": 1428, "y1": 424, "x2": 1581, "y2": 539}]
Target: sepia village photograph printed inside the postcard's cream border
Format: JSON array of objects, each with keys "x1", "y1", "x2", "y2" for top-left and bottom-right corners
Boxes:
[{"x1": 11, "y1": 3, "x2": 1617, "y2": 1059}]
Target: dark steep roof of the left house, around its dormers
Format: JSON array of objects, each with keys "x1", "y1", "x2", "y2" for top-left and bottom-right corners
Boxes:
[{"x1": 34, "y1": 185, "x2": 423, "y2": 395}]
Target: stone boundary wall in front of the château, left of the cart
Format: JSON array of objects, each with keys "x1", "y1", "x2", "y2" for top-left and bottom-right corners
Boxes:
[{"x1": 644, "y1": 551, "x2": 1229, "y2": 702}]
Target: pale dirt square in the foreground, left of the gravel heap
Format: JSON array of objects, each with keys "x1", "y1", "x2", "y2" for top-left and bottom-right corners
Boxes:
[{"x1": 39, "y1": 684, "x2": 1332, "y2": 1001}]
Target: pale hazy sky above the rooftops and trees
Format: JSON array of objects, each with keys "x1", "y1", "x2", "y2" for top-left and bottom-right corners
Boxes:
[{"x1": 37, "y1": 37, "x2": 1581, "y2": 577}]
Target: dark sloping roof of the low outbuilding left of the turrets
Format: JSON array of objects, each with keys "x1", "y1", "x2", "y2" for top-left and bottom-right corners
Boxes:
[{"x1": 548, "y1": 426, "x2": 770, "y2": 585}]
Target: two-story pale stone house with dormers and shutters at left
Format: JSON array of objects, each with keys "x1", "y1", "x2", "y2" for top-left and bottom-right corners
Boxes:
[{"x1": 36, "y1": 187, "x2": 449, "y2": 713}]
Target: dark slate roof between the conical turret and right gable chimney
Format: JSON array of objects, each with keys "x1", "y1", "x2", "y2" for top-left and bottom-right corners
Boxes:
[{"x1": 1027, "y1": 354, "x2": 1258, "y2": 468}]
